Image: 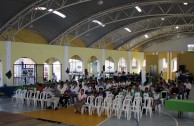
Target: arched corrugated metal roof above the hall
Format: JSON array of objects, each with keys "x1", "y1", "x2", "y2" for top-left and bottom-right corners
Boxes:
[{"x1": 0, "y1": 0, "x2": 194, "y2": 49}]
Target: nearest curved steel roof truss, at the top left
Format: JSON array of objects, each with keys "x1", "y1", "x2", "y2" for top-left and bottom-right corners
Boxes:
[{"x1": 0, "y1": 0, "x2": 91, "y2": 39}]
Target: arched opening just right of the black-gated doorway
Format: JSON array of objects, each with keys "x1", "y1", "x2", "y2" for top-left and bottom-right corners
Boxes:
[{"x1": 44, "y1": 57, "x2": 62, "y2": 82}]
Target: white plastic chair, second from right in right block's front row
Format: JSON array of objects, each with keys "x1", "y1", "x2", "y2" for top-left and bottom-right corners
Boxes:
[{"x1": 131, "y1": 97, "x2": 142, "y2": 121}]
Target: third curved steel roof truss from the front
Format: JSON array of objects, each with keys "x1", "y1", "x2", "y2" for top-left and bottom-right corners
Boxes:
[{"x1": 103, "y1": 15, "x2": 194, "y2": 48}]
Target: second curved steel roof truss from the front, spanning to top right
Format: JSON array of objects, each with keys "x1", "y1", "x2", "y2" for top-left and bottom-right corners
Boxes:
[{"x1": 50, "y1": 0, "x2": 194, "y2": 47}]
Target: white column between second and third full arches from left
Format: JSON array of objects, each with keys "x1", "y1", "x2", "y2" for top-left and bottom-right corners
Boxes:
[{"x1": 63, "y1": 46, "x2": 70, "y2": 81}]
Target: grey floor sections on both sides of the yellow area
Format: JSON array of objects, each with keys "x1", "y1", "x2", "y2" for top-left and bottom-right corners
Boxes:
[{"x1": 0, "y1": 90, "x2": 194, "y2": 126}]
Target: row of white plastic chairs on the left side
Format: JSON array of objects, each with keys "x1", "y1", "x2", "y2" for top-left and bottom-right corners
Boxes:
[{"x1": 12, "y1": 89, "x2": 52, "y2": 108}]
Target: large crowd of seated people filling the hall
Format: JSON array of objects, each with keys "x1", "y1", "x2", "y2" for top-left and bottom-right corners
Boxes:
[{"x1": 19, "y1": 73, "x2": 191, "y2": 113}]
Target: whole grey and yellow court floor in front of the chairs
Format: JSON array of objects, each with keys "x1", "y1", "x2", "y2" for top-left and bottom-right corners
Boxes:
[{"x1": 0, "y1": 87, "x2": 194, "y2": 126}]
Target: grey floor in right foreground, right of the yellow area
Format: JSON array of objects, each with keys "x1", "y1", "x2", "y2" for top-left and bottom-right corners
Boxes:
[{"x1": 99, "y1": 89, "x2": 194, "y2": 126}]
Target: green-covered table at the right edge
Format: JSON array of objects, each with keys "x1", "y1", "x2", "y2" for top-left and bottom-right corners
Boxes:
[{"x1": 165, "y1": 99, "x2": 194, "y2": 118}]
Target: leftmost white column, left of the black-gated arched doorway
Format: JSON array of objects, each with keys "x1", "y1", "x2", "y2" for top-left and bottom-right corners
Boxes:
[{"x1": 5, "y1": 41, "x2": 13, "y2": 86}]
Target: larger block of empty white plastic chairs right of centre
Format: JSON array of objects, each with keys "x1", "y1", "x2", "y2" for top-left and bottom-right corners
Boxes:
[{"x1": 81, "y1": 94, "x2": 161, "y2": 121}]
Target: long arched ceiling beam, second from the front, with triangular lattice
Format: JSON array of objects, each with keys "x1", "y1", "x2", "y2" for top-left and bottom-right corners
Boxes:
[{"x1": 50, "y1": 0, "x2": 194, "y2": 47}]
